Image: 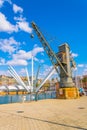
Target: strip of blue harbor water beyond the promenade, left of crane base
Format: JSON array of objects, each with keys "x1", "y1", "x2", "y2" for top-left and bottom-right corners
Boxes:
[{"x1": 0, "y1": 91, "x2": 56, "y2": 104}]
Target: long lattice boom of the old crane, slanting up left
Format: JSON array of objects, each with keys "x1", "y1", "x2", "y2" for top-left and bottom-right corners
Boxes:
[{"x1": 31, "y1": 22, "x2": 68, "y2": 76}]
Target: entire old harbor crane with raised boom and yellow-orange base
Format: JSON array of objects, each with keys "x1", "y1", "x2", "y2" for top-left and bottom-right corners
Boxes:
[{"x1": 32, "y1": 22, "x2": 78, "y2": 98}]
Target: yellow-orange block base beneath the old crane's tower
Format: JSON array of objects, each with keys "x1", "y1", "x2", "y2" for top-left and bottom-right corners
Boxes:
[{"x1": 57, "y1": 87, "x2": 79, "y2": 99}]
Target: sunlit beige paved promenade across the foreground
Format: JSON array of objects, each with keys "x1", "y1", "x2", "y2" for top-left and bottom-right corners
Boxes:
[{"x1": 0, "y1": 96, "x2": 87, "y2": 130}]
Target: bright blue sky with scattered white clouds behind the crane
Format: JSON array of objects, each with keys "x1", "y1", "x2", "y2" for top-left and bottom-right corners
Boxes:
[{"x1": 0, "y1": 0, "x2": 87, "y2": 76}]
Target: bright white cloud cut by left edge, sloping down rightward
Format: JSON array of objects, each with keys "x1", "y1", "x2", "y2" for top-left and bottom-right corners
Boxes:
[{"x1": 0, "y1": 12, "x2": 18, "y2": 33}]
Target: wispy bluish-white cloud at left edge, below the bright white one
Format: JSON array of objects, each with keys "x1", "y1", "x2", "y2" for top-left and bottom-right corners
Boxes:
[{"x1": 0, "y1": 37, "x2": 20, "y2": 54}]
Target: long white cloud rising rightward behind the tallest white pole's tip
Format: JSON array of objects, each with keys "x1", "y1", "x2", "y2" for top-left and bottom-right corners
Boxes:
[{"x1": 7, "y1": 47, "x2": 44, "y2": 65}]
